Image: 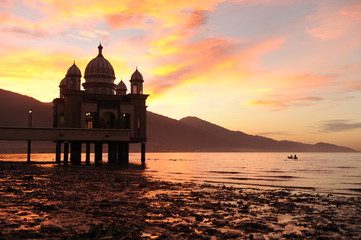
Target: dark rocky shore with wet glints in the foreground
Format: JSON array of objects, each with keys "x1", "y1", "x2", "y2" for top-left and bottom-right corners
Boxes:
[{"x1": 0, "y1": 162, "x2": 361, "y2": 240}]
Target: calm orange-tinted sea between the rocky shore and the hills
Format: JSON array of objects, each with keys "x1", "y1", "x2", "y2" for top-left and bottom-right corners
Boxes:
[{"x1": 0, "y1": 153, "x2": 361, "y2": 196}]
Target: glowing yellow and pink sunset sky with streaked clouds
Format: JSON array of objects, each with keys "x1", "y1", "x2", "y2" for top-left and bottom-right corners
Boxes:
[{"x1": 0, "y1": 0, "x2": 361, "y2": 151}]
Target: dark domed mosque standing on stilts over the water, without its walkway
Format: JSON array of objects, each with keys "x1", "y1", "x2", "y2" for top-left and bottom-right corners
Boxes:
[{"x1": 53, "y1": 44, "x2": 149, "y2": 165}]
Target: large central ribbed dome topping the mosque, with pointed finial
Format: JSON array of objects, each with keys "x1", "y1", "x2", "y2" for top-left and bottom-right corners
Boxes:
[{"x1": 84, "y1": 44, "x2": 115, "y2": 83}]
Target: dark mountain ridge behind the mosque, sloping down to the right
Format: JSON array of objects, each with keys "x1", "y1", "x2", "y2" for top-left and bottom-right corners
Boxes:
[{"x1": 0, "y1": 89, "x2": 355, "y2": 152}]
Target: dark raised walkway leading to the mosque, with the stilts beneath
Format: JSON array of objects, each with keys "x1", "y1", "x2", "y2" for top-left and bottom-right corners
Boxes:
[{"x1": 0, "y1": 127, "x2": 145, "y2": 166}]
